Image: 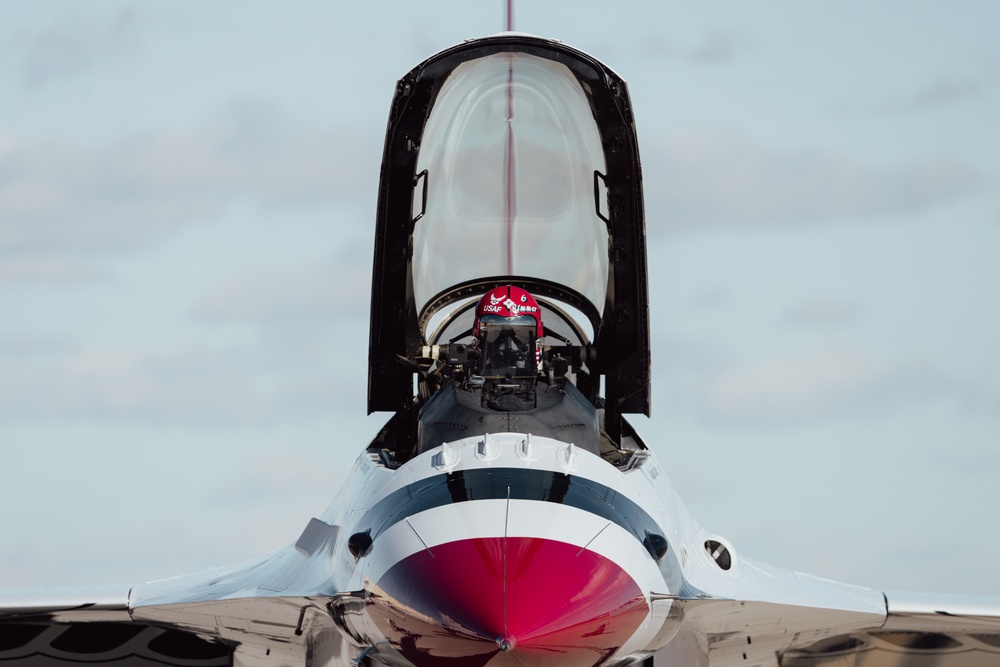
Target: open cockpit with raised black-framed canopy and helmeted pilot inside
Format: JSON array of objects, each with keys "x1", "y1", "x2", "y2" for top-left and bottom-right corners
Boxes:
[{"x1": 369, "y1": 34, "x2": 649, "y2": 468}]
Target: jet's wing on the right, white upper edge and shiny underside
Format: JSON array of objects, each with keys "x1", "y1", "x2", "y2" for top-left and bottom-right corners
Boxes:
[{"x1": 655, "y1": 559, "x2": 1000, "y2": 667}]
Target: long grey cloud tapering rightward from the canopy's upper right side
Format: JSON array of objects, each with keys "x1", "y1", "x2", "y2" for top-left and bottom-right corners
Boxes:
[{"x1": 643, "y1": 129, "x2": 984, "y2": 234}]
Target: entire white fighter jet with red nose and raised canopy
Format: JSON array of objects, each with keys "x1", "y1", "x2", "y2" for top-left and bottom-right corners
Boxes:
[{"x1": 0, "y1": 32, "x2": 1000, "y2": 667}]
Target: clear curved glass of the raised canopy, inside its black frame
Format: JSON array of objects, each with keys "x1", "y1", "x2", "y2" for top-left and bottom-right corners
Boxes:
[{"x1": 413, "y1": 53, "x2": 608, "y2": 333}]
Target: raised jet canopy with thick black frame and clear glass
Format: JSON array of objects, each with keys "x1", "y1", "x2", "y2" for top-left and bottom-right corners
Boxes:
[{"x1": 368, "y1": 33, "x2": 649, "y2": 432}]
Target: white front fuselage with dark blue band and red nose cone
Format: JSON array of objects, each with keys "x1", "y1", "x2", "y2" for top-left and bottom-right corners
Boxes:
[{"x1": 328, "y1": 433, "x2": 688, "y2": 667}]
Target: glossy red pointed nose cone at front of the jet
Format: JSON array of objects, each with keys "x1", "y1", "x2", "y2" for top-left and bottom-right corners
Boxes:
[{"x1": 368, "y1": 537, "x2": 648, "y2": 667}]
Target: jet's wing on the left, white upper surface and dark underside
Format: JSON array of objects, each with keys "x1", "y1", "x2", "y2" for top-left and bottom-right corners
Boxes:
[{"x1": 0, "y1": 519, "x2": 358, "y2": 667}]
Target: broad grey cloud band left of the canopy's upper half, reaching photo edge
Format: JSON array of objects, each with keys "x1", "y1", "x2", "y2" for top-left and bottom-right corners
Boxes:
[{"x1": 0, "y1": 101, "x2": 379, "y2": 255}]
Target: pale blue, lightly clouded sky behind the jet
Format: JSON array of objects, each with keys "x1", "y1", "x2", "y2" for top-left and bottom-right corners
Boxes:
[{"x1": 0, "y1": 0, "x2": 1000, "y2": 596}]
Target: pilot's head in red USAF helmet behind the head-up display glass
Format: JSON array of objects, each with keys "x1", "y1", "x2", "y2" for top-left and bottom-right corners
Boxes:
[{"x1": 472, "y1": 285, "x2": 545, "y2": 377}]
